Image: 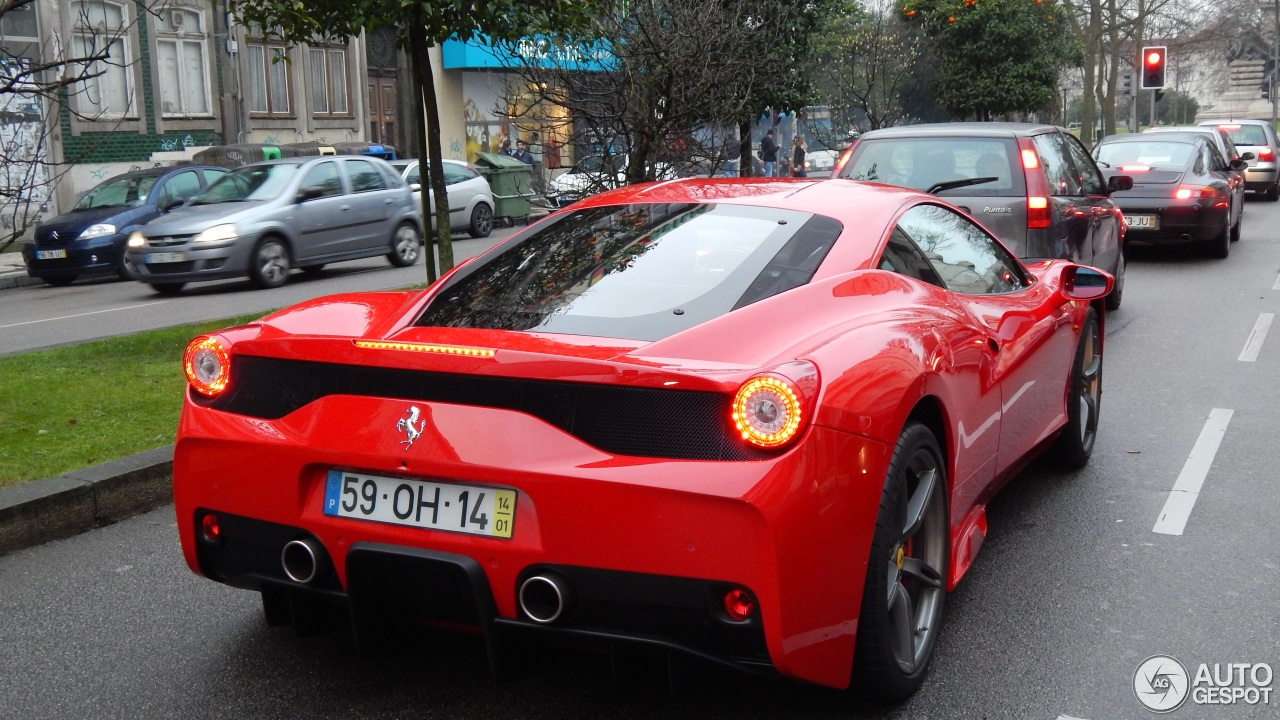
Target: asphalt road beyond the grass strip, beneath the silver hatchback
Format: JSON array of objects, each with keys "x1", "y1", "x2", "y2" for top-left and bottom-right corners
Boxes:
[{"x1": 0, "y1": 225, "x2": 524, "y2": 355}]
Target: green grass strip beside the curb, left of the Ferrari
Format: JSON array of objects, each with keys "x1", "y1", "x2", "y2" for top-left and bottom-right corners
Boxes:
[{"x1": 0, "y1": 313, "x2": 264, "y2": 487}]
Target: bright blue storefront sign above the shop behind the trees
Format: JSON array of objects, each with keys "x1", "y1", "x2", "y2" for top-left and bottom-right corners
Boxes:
[{"x1": 440, "y1": 37, "x2": 614, "y2": 72}]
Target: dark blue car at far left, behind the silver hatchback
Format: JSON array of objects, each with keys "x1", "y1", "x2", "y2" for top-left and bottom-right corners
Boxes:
[{"x1": 22, "y1": 165, "x2": 227, "y2": 286}]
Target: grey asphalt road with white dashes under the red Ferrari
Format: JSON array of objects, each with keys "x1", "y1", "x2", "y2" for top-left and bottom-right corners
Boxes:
[{"x1": 0, "y1": 201, "x2": 1280, "y2": 720}]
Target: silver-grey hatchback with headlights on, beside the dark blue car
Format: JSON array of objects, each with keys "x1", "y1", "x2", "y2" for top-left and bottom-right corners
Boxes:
[{"x1": 128, "y1": 155, "x2": 422, "y2": 293}]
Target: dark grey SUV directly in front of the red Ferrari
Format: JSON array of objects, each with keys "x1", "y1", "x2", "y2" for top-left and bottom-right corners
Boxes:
[{"x1": 831, "y1": 123, "x2": 1133, "y2": 310}]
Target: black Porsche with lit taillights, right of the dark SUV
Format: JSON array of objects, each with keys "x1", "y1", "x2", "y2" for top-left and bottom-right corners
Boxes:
[{"x1": 1093, "y1": 132, "x2": 1245, "y2": 258}]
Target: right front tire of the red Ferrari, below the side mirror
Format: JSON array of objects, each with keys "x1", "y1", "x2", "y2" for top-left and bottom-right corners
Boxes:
[{"x1": 1053, "y1": 307, "x2": 1102, "y2": 469}]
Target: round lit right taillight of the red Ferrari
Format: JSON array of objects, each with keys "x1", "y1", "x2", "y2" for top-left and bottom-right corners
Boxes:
[{"x1": 731, "y1": 361, "x2": 818, "y2": 450}]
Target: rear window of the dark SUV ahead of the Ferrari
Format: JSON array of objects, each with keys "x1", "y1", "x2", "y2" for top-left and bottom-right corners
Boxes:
[{"x1": 841, "y1": 137, "x2": 1025, "y2": 197}]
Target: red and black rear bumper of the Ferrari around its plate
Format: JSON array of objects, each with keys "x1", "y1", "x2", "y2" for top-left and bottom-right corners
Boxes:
[{"x1": 174, "y1": 396, "x2": 891, "y2": 687}]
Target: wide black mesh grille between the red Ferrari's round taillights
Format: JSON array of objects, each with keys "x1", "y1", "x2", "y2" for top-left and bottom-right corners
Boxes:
[{"x1": 192, "y1": 356, "x2": 768, "y2": 460}]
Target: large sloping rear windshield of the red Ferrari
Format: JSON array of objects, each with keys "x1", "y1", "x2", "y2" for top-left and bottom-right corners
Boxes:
[{"x1": 416, "y1": 198, "x2": 841, "y2": 341}]
